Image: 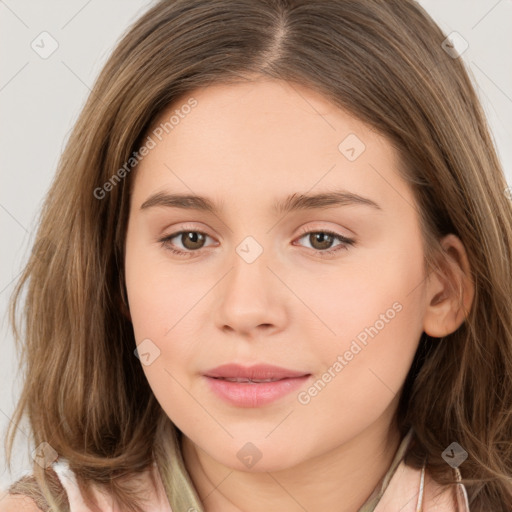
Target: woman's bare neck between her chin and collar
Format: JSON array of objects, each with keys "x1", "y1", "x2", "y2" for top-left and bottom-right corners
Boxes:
[{"x1": 182, "y1": 412, "x2": 401, "y2": 512}]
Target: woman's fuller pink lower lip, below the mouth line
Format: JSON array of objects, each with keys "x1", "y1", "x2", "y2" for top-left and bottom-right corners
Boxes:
[{"x1": 206, "y1": 375, "x2": 310, "y2": 407}]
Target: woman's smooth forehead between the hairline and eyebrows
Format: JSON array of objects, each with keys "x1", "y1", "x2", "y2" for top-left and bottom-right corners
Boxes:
[{"x1": 130, "y1": 80, "x2": 412, "y2": 216}]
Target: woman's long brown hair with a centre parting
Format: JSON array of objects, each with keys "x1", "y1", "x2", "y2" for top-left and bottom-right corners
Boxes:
[{"x1": 6, "y1": 0, "x2": 512, "y2": 512}]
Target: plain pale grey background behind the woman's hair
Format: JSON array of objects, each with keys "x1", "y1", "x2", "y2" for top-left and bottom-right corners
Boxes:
[{"x1": 0, "y1": 0, "x2": 512, "y2": 488}]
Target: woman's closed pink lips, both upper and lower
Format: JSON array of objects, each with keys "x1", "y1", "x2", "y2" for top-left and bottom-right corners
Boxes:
[{"x1": 205, "y1": 364, "x2": 311, "y2": 407}]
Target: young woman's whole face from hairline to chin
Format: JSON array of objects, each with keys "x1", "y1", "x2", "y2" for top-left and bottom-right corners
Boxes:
[{"x1": 125, "y1": 81, "x2": 425, "y2": 471}]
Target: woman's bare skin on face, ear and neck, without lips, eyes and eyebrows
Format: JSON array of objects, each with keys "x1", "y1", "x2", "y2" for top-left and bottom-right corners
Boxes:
[{"x1": 125, "y1": 80, "x2": 473, "y2": 512}]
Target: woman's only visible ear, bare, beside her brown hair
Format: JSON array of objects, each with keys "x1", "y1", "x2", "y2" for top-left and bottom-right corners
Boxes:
[{"x1": 423, "y1": 234, "x2": 475, "y2": 338}]
